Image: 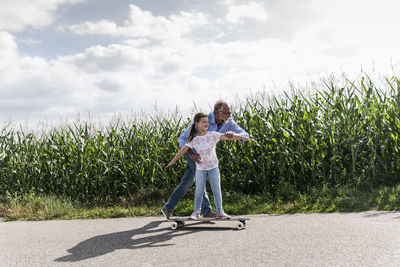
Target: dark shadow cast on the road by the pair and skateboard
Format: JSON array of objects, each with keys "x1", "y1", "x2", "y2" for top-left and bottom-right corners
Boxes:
[{"x1": 55, "y1": 220, "x2": 233, "y2": 262}]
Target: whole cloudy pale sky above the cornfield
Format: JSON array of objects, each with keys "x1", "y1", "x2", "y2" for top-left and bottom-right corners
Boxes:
[{"x1": 0, "y1": 0, "x2": 400, "y2": 126}]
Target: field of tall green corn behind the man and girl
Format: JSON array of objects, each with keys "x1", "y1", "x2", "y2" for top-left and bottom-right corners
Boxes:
[{"x1": 0, "y1": 77, "x2": 400, "y2": 203}]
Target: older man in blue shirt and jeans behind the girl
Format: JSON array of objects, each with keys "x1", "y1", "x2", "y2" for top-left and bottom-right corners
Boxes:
[{"x1": 161, "y1": 100, "x2": 249, "y2": 219}]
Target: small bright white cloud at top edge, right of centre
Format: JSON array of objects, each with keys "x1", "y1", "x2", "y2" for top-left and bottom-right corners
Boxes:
[{"x1": 225, "y1": 2, "x2": 268, "y2": 23}]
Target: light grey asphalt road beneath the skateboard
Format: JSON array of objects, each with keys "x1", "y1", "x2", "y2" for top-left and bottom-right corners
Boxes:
[{"x1": 0, "y1": 212, "x2": 400, "y2": 267}]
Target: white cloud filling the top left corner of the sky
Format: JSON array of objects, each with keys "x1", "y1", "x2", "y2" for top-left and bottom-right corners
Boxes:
[{"x1": 0, "y1": 0, "x2": 83, "y2": 32}]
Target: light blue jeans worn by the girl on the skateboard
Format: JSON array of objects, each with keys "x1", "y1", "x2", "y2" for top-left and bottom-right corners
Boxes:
[{"x1": 194, "y1": 167, "x2": 222, "y2": 213}]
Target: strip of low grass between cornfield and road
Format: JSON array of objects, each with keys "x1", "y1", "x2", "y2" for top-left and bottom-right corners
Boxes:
[{"x1": 0, "y1": 185, "x2": 400, "y2": 221}]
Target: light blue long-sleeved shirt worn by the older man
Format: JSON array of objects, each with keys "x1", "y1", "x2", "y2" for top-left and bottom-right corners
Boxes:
[{"x1": 178, "y1": 112, "x2": 249, "y2": 148}]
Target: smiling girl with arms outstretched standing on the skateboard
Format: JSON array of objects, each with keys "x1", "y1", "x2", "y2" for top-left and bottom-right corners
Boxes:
[{"x1": 167, "y1": 113, "x2": 253, "y2": 219}]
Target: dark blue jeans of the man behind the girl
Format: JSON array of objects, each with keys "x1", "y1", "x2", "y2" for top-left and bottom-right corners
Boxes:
[{"x1": 164, "y1": 153, "x2": 211, "y2": 215}]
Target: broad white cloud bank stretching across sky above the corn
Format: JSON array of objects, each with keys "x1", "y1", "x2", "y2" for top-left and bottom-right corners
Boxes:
[{"x1": 0, "y1": 0, "x2": 400, "y2": 126}]
